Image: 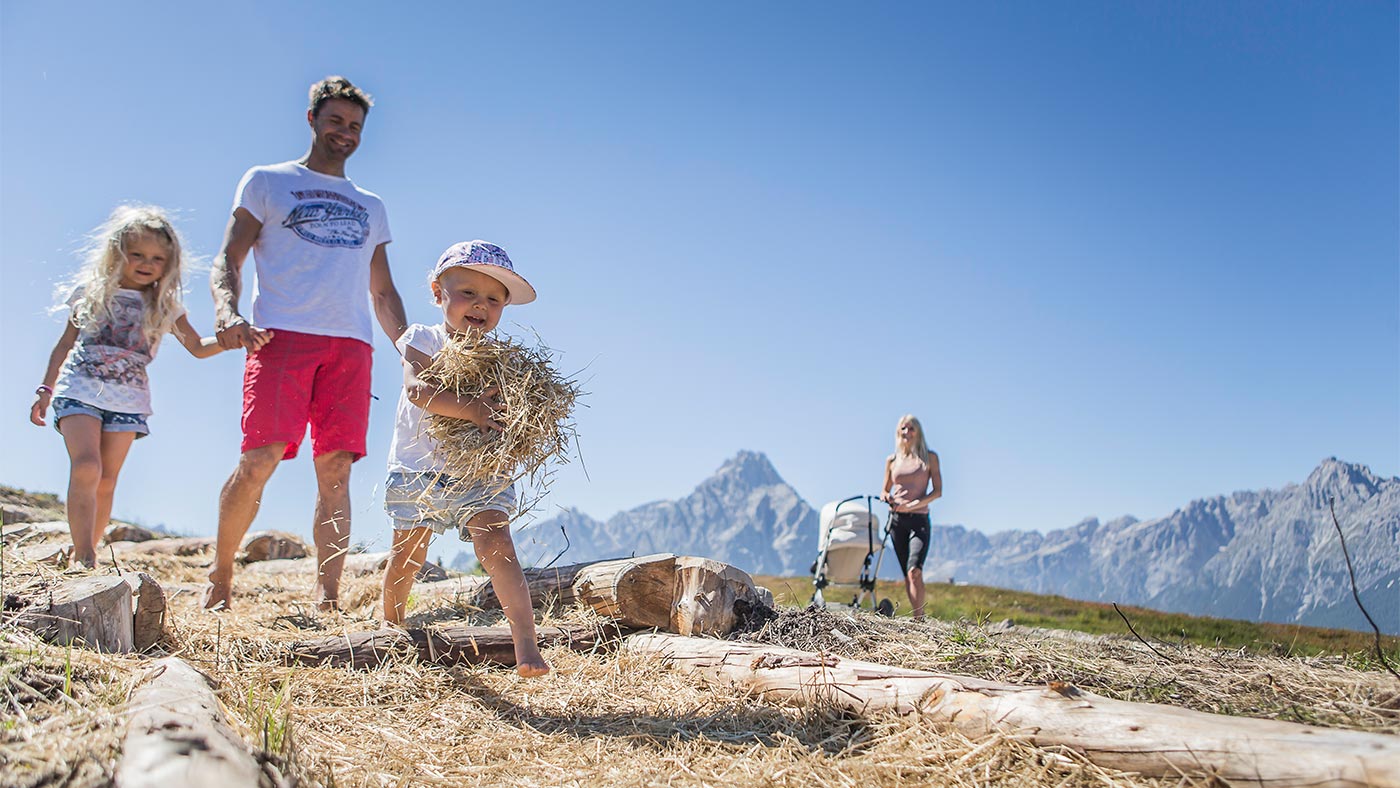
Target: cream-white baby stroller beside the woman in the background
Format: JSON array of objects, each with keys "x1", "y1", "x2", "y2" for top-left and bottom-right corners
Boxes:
[{"x1": 812, "y1": 495, "x2": 895, "y2": 616}]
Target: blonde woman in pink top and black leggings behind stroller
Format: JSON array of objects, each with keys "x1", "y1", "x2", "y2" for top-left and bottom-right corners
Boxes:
[{"x1": 881, "y1": 416, "x2": 944, "y2": 620}]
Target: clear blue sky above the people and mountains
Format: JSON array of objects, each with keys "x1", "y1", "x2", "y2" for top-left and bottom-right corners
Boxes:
[{"x1": 0, "y1": 0, "x2": 1400, "y2": 554}]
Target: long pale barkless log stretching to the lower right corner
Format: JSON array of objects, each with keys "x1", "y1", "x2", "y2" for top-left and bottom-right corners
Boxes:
[{"x1": 623, "y1": 634, "x2": 1400, "y2": 788}]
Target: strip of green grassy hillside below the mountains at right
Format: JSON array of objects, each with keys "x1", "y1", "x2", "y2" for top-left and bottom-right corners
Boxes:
[{"x1": 755, "y1": 577, "x2": 1400, "y2": 669}]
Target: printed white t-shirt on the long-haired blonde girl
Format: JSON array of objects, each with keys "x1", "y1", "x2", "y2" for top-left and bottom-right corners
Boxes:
[{"x1": 53, "y1": 288, "x2": 183, "y2": 416}]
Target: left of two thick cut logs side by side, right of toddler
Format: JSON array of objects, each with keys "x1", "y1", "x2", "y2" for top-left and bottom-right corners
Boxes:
[{"x1": 574, "y1": 553, "x2": 676, "y2": 630}]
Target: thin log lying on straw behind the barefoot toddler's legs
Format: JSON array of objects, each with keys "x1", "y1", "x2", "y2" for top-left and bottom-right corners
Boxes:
[{"x1": 288, "y1": 627, "x2": 620, "y2": 668}]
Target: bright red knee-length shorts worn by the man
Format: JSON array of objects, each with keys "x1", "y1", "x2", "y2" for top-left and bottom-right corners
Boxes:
[{"x1": 242, "y1": 329, "x2": 372, "y2": 459}]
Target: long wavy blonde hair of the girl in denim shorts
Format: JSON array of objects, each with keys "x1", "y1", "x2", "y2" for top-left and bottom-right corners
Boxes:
[{"x1": 62, "y1": 206, "x2": 185, "y2": 349}]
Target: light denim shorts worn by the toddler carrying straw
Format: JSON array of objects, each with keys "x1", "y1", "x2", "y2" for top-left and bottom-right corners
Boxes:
[{"x1": 384, "y1": 472, "x2": 515, "y2": 542}]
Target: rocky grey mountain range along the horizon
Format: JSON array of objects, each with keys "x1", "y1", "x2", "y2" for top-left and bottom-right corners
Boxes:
[{"x1": 498, "y1": 451, "x2": 1400, "y2": 634}]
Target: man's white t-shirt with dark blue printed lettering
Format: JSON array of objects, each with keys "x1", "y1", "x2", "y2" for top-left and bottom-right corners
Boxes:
[{"x1": 234, "y1": 161, "x2": 392, "y2": 344}]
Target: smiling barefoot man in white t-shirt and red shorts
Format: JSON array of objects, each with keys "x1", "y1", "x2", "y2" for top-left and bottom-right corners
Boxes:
[{"x1": 204, "y1": 77, "x2": 407, "y2": 610}]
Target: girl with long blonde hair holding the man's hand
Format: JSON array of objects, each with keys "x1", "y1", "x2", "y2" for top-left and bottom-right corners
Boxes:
[{"x1": 29, "y1": 206, "x2": 272, "y2": 567}]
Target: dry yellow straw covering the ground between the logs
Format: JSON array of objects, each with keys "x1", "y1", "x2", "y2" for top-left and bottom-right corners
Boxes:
[{"x1": 8, "y1": 489, "x2": 1400, "y2": 787}]
